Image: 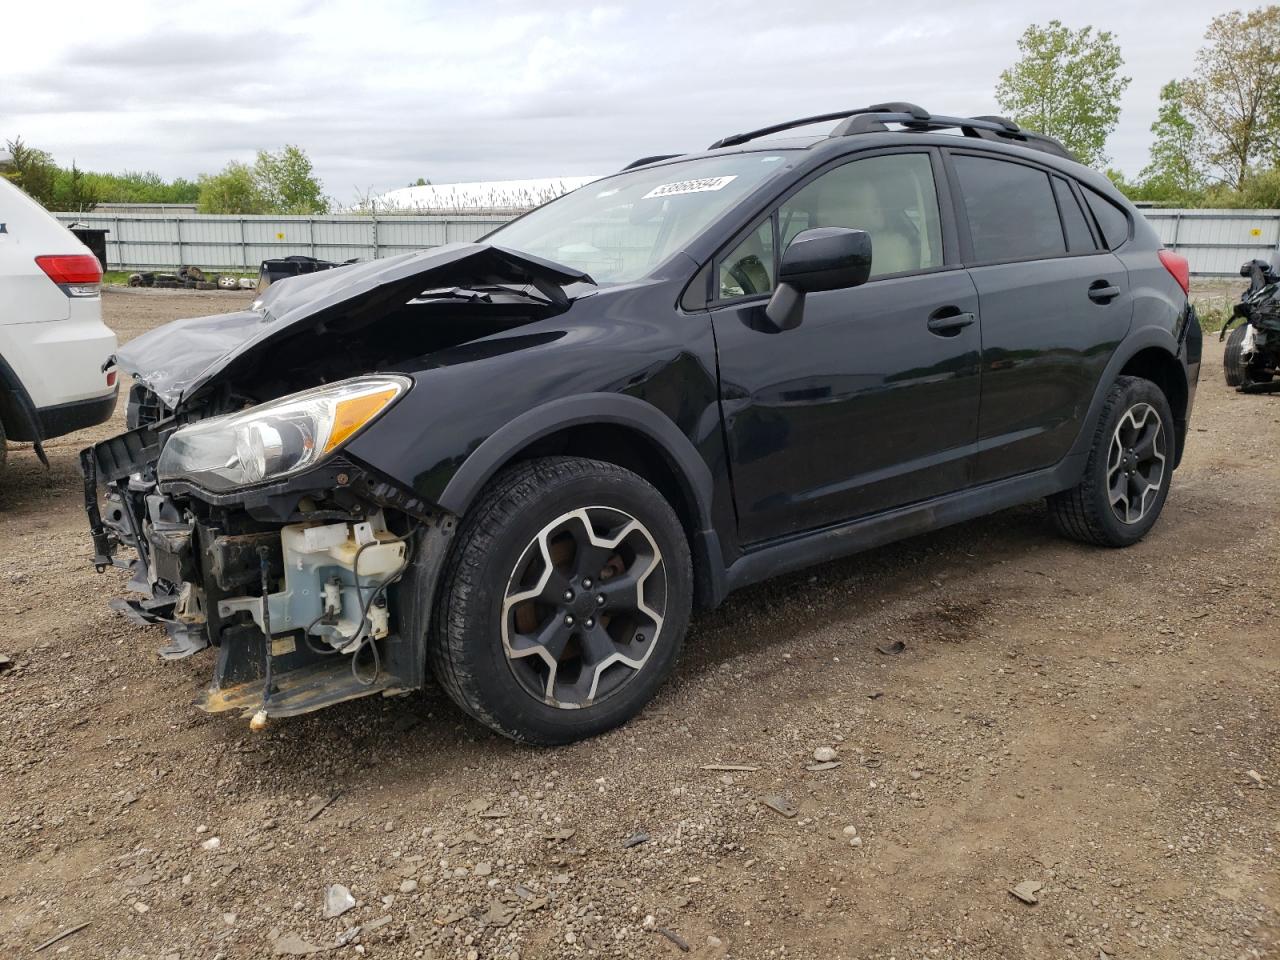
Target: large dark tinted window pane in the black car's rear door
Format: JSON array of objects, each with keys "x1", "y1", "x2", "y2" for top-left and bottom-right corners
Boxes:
[{"x1": 952, "y1": 156, "x2": 1066, "y2": 264}]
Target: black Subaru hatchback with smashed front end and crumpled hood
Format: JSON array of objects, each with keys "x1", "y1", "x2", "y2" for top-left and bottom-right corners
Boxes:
[{"x1": 82, "y1": 104, "x2": 1201, "y2": 744}]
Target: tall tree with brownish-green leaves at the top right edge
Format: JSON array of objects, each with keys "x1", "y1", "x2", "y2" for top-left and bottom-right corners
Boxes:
[{"x1": 1181, "y1": 5, "x2": 1280, "y2": 189}]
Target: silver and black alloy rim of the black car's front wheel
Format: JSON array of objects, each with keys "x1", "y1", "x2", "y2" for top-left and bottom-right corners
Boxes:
[{"x1": 502, "y1": 507, "x2": 667, "y2": 709}]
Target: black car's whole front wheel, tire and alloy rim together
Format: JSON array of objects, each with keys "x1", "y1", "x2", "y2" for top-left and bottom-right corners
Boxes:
[{"x1": 428, "y1": 457, "x2": 692, "y2": 746}]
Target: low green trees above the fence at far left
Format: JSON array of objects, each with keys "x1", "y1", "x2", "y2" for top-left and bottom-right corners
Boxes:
[{"x1": 0, "y1": 137, "x2": 333, "y2": 214}]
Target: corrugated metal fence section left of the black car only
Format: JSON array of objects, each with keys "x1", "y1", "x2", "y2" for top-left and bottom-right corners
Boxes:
[{"x1": 55, "y1": 212, "x2": 512, "y2": 273}]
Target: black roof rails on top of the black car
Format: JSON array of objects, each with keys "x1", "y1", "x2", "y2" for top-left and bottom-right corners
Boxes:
[{"x1": 709, "y1": 102, "x2": 1075, "y2": 160}]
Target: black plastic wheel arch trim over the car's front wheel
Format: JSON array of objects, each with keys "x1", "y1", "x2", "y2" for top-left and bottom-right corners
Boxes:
[{"x1": 436, "y1": 393, "x2": 726, "y2": 605}]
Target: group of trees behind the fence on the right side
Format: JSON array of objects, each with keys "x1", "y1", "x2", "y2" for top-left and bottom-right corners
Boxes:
[{"x1": 996, "y1": 5, "x2": 1280, "y2": 207}]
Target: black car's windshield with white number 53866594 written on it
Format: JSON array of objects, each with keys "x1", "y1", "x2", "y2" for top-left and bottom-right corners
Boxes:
[{"x1": 489, "y1": 151, "x2": 787, "y2": 285}]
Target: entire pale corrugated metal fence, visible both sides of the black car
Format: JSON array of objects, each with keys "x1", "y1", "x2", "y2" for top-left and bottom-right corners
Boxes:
[{"x1": 55, "y1": 209, "x2": 1280, "y2": 276}]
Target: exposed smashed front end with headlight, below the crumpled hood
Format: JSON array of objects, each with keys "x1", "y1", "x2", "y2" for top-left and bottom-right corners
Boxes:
[{"x1": 81, "y1": 376, "x2": 452, "y2": 722}]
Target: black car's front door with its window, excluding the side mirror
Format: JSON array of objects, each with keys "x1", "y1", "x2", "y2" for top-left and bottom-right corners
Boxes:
[{"x1": 712, "y1": 148, "x2": 980, "y2": 544}]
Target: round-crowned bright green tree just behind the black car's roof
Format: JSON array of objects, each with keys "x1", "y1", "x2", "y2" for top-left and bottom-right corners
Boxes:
[{"x1": 996, "y1": 20, "x2": 1130, "y2": 166}]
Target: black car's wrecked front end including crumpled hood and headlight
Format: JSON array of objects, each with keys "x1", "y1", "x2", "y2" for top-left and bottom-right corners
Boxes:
[{"x1": 81, "y1": 243, "x2": 590, "y2": 719}]
